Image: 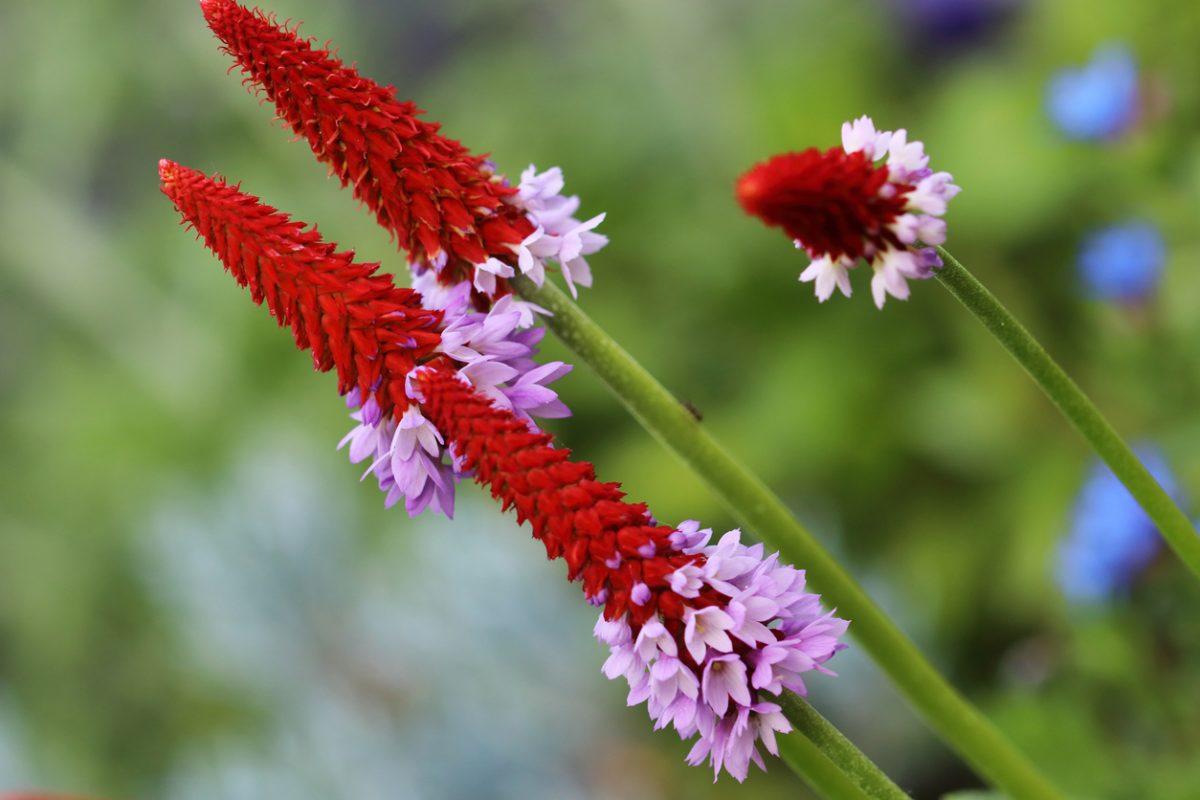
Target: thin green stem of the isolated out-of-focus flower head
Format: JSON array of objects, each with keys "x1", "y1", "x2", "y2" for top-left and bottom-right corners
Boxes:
[{"x1": 937, "y1": 247, "x2": 1200, "y2": 577}]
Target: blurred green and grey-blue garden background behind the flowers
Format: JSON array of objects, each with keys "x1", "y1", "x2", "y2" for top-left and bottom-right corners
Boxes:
[{"x1": 7, "y1": 0, "x2": 1200, "y2": 800}]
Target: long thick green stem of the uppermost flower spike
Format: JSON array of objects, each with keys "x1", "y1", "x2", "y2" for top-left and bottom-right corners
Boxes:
[{"x1": 512, "y1": 276, "x2": 1061, "y2": 799}]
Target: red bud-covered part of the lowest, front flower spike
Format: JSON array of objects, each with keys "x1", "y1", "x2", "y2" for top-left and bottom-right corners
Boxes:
[{"x1": 414, "y1": 369, "x2": 726, "y2": 633}]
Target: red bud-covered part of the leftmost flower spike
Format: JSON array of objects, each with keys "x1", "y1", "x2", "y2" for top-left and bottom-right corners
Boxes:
[{"x1": 158, "y1": 160, "x2": 440, "y2": 414}]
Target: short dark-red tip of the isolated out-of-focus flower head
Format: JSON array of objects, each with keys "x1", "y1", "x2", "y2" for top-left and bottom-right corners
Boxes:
[{"x1": 737, "y1": 148, "x2": 914, "y2": 259}]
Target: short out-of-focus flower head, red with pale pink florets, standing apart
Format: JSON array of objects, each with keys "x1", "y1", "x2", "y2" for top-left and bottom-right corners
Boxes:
[{"x1": 737, "y1": 116, "x2": 959, "y2": 308}]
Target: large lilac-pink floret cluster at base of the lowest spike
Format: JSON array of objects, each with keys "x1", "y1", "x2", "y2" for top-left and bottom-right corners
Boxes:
[{"x1": 595, "y1": 521, "x2": 848, "y2": 781}]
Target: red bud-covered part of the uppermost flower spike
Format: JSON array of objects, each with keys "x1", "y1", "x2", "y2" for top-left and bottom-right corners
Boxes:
[{"x1": 200, "y1": 0, "x2": 534, "y2": 285}]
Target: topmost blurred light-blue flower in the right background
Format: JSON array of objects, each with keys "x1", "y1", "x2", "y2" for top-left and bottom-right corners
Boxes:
[{"x1": 1046, "y1": 44, "x2": 1138, "y2": 139}]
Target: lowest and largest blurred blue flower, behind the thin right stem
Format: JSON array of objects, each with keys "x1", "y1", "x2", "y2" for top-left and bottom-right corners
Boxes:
[{"x1": 1057, "y1": 447, "x2": 1178, "y2": 603}]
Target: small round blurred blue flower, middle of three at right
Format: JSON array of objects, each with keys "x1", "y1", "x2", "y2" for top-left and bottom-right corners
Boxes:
[{"x1": 1079, "y1": 222, "x2": 1166, "y2": 301}]
